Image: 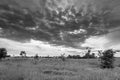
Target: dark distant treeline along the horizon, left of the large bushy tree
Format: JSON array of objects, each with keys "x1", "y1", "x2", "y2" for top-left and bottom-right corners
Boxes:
[{"x1": 0, "y1": 48, "x2": 96, "y2": 59}]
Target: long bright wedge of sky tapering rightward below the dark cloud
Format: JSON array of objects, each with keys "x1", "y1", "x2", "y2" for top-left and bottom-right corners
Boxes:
[{"x1": 0, "y1": 38, "x2": 82, "y2": 56}]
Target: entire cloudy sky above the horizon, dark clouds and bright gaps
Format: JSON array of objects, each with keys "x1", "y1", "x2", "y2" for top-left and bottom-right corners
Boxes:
[{"x1": 0, "y1": 0, "x2": 120, "y2": 56}]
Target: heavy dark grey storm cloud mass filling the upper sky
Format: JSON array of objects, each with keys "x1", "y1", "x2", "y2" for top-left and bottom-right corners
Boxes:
[{"x1": 0, "y1": 0, "x2": 120, "y2": 47}]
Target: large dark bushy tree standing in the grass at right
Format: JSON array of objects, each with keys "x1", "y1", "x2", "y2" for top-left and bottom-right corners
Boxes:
[{"x1": 99, "y1": 49, "x2": 115, "y2": 68}]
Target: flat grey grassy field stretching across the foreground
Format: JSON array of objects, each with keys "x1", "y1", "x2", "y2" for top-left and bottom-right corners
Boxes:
[{"x1": 0, "y1": 58, "x2": 120, "y2": 80}]
